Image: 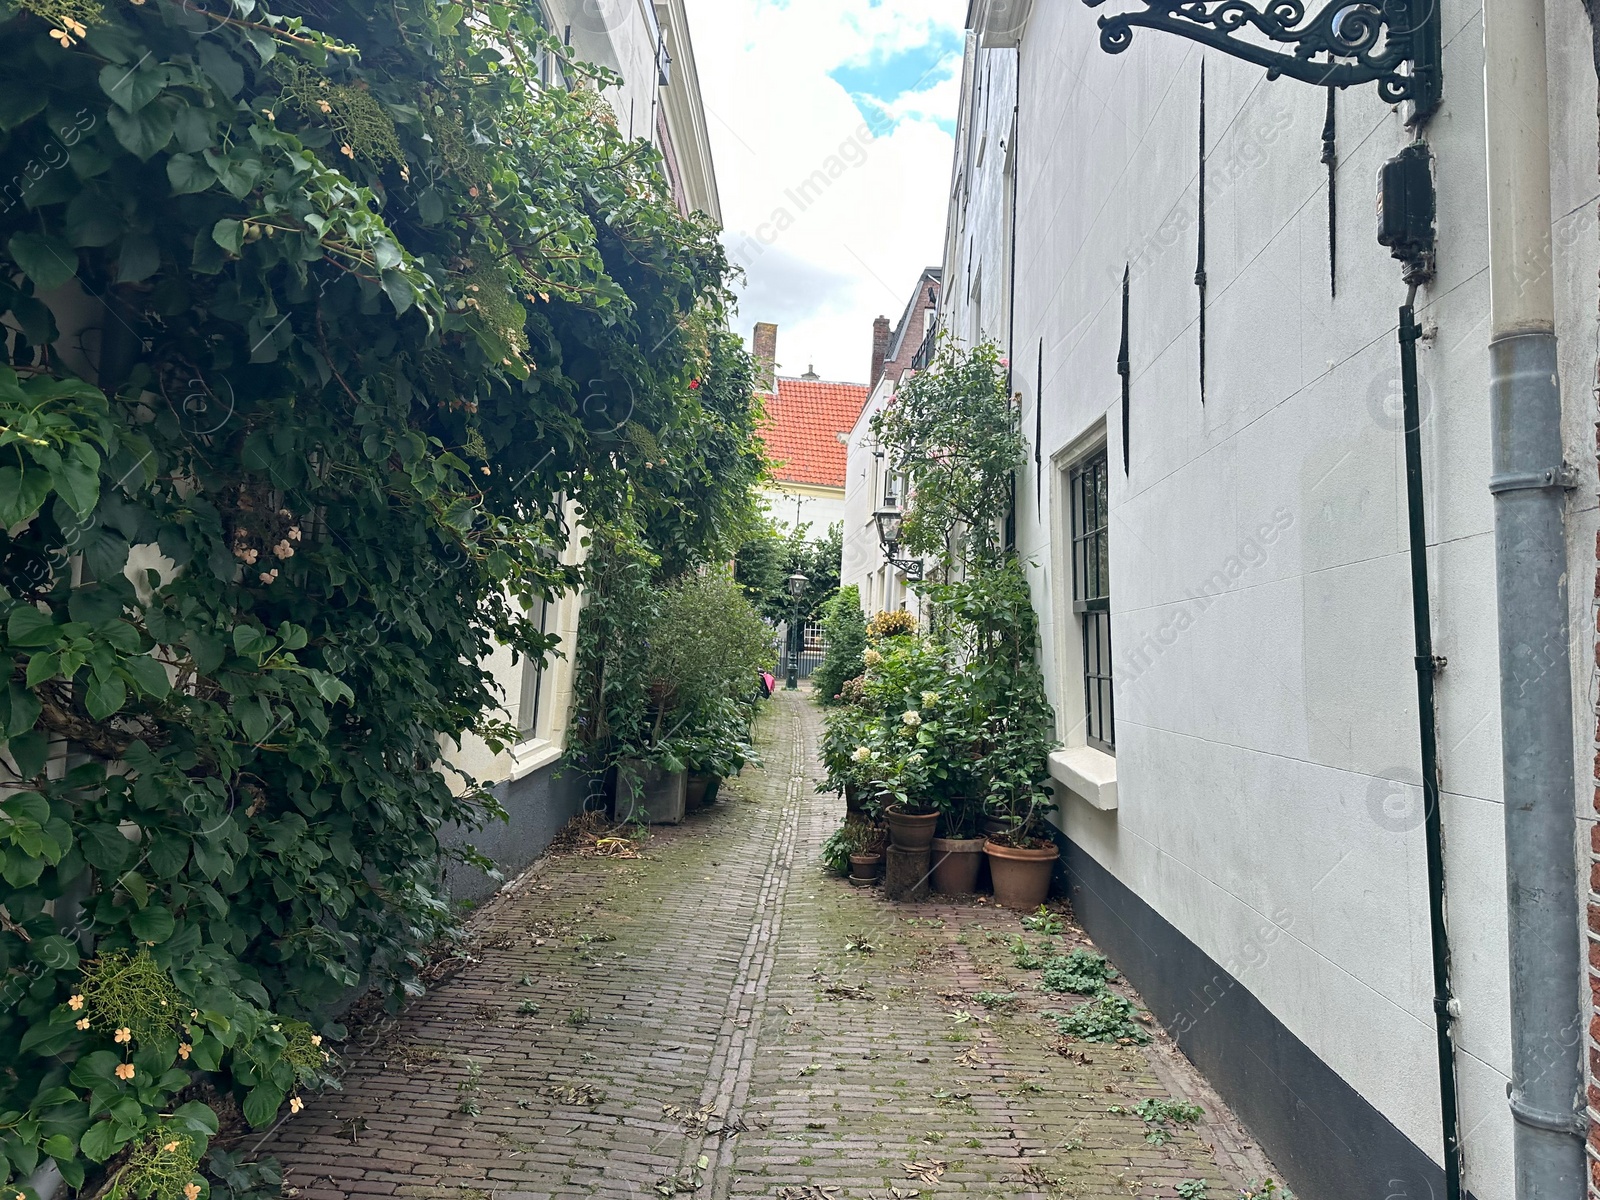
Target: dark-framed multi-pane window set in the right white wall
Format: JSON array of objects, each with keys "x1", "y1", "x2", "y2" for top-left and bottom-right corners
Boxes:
[{"x1": 1067, "y1": 448, "x2": 1117, "y2": 754}]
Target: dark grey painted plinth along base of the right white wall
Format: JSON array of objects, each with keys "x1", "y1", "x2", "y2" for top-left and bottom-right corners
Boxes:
[{"x1": 1058, "y1": 842, "x2": 1472, "y2": 1200}]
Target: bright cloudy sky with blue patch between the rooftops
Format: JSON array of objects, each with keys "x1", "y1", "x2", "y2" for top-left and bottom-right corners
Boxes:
[{"x1": 686, "y1": 0, "x2": 966, "y2": 382}]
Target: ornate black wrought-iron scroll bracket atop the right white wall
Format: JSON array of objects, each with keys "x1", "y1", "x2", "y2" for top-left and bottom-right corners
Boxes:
[{"x1": 1083, "y1": 0, "x2": 1442, "y2": 123}]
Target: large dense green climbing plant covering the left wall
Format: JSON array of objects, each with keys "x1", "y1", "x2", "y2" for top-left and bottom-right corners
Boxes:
[{"x1": 0, "y1": 0, "x2": 760, "y2": 1200}]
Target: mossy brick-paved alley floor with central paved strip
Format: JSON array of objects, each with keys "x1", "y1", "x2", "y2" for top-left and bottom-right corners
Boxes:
[{"x1": 264, "y1": 693, "x2": 1270, "y2": 1200}]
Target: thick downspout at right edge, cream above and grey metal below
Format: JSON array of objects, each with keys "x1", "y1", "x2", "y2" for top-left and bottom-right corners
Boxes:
[{"x1": 1483, "y1": 0, "x2": 1587, "y2": 1200}]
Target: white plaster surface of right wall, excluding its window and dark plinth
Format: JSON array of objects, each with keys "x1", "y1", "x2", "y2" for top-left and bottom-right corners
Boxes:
[{"x1": 941, "y1": 0, "x2": 1600, "y2": 1197}]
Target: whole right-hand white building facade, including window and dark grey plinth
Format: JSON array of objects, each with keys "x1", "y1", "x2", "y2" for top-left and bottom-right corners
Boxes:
[{"x1": 921, "y1": 0, "x2": 1600, "y2": 1200}]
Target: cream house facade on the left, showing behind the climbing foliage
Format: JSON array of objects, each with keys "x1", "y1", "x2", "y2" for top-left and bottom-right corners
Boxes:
[{"x1": 435, "y1": 0, "x2": 722, "y2": 899}]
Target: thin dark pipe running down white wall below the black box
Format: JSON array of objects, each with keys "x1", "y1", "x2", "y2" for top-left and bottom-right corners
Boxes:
[{"x1": 1400, "y1": 294, "x2": 1462, "y2": 1200}]
